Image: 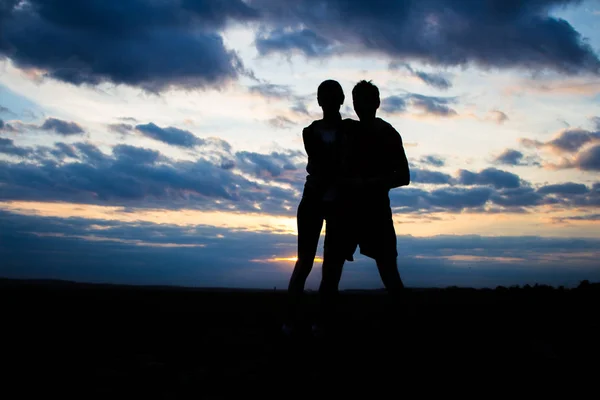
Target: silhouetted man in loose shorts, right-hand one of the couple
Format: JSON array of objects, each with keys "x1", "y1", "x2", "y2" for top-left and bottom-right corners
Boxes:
[{"x1": 319, "y1": 80, "x2": 410, "y2": 330}]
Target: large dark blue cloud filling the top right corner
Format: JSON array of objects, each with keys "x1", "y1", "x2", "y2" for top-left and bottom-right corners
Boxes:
[{"x1": 249, "y1": 0, "x2": 600, "y2": 74}]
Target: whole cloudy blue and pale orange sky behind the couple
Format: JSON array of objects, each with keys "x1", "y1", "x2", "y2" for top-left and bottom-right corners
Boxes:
[{"x1": 0, "y1": 0, "x2": 600, "y2": 288}]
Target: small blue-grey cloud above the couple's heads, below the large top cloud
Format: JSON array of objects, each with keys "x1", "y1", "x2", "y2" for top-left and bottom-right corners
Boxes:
[{"x1": 255, "y1": 29, "x2": 332, "y2": 57}]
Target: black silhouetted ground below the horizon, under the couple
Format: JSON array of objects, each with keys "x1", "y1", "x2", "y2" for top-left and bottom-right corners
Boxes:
[{"x1": 0, "y1": 280, "x2": 600, "y2": 398}]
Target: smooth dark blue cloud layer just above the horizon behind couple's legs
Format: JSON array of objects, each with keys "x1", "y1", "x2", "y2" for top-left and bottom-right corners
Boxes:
[{"x1": 0, "y1": 211, "x2": 600, "y2": 289}]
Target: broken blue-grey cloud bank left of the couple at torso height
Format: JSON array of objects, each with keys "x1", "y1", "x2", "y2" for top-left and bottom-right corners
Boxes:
[{"x1": 0, "y1": 138, "x2": 305, "y2": 215}]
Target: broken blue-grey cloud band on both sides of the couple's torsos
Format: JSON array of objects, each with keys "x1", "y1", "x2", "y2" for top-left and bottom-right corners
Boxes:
[{"x1": 0, "y1": 138, "x2": 600, "y2": 216}]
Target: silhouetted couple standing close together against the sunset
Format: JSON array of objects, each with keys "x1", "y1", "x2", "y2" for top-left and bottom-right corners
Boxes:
[{"x1": 283, "y1": 80, "x2": 410, "y2": 334}]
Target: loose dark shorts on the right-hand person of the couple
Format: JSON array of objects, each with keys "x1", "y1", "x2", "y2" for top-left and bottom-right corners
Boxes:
[{"x1": 325, "y1": 198, "x2": 398, "y2": 261}]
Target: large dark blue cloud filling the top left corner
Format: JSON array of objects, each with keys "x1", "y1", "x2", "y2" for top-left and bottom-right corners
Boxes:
[{"x1": 0, "y1": 0, "x2": 248, "y2": 92}]
